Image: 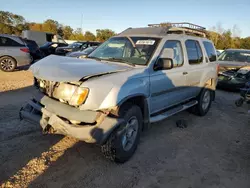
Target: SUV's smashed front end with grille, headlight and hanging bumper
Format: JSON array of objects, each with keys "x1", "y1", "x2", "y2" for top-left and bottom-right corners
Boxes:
[{"x1": 20, "y1": 78, "x2": 123, "y2": 144}]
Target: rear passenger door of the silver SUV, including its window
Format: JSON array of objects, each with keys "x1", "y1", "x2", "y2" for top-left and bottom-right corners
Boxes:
[{"x1": 185, "y1": 39, "x2": 206, "y2": 98}]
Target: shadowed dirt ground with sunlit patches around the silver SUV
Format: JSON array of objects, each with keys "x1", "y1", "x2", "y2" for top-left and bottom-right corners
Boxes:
[{"x1": 0, "y1": 71, "x2": 250, "y2": 188}]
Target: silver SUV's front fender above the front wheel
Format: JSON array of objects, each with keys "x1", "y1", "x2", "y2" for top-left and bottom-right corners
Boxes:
[{"x1": 99, "y1": 77, "x2": 149, "y2": 109}]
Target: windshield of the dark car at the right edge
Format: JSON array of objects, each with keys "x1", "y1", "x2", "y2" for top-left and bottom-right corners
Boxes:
[{"x1": 218, "y1": 50, "x2": 250, "y2": 63}]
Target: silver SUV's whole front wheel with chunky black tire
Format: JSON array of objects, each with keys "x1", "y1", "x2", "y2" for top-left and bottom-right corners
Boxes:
[{"x1": 101, "y1": 104, "x2": 143, "y2": 163}]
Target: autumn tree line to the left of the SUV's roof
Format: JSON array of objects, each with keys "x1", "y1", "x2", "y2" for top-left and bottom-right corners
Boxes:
[{"x1": 0, "y1": 11, "x2": 115, "y2": 42}]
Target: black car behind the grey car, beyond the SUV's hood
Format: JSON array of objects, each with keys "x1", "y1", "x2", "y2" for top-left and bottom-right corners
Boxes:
[{"x1": 56, "y1": 41, "x2": 100, "y2": 55}]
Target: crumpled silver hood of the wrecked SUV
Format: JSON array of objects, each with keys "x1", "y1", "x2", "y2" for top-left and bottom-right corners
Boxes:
[{"x1": 30, "y1": 55, "x2": 132, "y2": 82}]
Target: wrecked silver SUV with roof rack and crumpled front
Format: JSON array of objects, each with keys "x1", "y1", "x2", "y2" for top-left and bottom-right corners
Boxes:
[{"x1": 20, "y1": 23, "x2": 218, "y2": 163}]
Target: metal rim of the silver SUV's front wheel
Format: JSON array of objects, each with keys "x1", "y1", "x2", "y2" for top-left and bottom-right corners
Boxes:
[{"x1": 122, "y1": 116, "x2": 139, "y2": 151}]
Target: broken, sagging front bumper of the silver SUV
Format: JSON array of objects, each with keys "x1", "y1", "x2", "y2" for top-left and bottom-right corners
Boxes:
[{"x1": 19, "y1": 91, "x2": 124, "y2": 144}]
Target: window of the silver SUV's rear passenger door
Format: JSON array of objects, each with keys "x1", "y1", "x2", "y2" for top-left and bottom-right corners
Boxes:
[{"x1": 185, "y1": 40, "x2": 203, "y2": 65}]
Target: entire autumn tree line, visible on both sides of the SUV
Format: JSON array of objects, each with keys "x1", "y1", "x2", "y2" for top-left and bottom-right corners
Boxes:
[{"x1": 0, "y1": 11, "x2": 250, "y2": 49}]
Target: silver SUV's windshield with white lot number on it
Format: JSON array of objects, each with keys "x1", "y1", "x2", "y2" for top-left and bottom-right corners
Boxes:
[{"x1": 88, "y1": 37, "x2": 160, "y2": 65}]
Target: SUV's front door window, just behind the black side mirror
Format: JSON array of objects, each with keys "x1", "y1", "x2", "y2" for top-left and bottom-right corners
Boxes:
[{"x1": 164, "y1": 40, "x2": 184, "y2": 67}]
